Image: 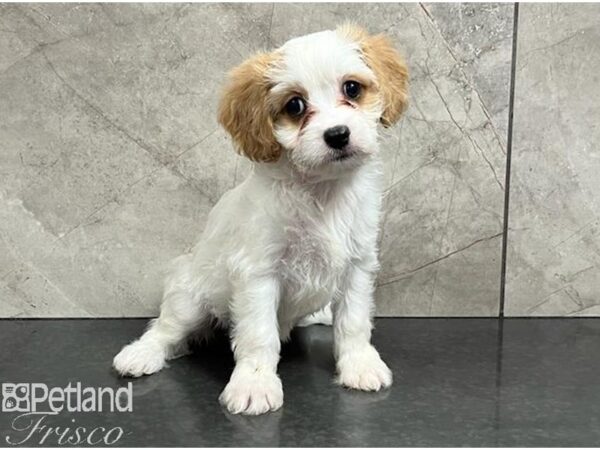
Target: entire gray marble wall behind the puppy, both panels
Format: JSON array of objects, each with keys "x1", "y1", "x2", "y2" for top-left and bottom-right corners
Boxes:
[{"x1": 0, "y1": 3, "x2": 600, "y2": 317}]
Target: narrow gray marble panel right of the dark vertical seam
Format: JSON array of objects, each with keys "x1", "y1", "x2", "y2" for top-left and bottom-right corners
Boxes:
[{"x1": 506, "y1": 4, "x2": 600, "y2": 316}]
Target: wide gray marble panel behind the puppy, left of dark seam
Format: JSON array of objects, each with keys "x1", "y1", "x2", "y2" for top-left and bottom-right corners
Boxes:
[{"x1": 0, "y1": 4, "x2": 512, "y2": 316}]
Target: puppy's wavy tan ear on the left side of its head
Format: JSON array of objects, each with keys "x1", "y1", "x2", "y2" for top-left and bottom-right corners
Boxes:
[{"x1": 219, "y1": 53, "x2": 281, "y2": 162}]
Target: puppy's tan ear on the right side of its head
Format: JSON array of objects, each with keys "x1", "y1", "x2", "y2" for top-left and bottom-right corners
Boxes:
[{"x1": 337, "y1": 24, "x2": 408, "y2": 127}]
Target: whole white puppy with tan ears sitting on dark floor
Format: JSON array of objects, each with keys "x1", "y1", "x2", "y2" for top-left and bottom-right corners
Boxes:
[{"x1": 113, "y1": 25, "x2": 408, "y2": 414}]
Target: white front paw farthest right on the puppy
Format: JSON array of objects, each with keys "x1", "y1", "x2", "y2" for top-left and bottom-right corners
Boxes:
[{"x1": 337, "y1": 345, "x2": 392, "y2": 391}]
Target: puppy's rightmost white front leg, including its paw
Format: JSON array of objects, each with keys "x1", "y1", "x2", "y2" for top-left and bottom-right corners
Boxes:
[{"x1": 333, "y1": 265, "x2": 392, "y2": 391}]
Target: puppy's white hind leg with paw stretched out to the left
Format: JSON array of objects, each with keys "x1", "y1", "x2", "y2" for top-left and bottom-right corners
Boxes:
[{"x1": 113, "y1": 255, "x2": 212, "y2": 377}]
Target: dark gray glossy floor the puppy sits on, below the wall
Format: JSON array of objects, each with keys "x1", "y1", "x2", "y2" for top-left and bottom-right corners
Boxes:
[{"x1": 0, "y1": 319, "x2": 600, "y2": 446}]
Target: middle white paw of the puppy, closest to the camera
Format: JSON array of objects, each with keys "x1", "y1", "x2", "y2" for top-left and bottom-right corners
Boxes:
[{"x1": 219, "y1": 368, "x2": 283, "y2": 415}]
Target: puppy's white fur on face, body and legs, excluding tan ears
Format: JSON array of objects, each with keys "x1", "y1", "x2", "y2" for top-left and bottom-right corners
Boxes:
[{"x1": 113, "y1": 31, "x2": 392, "y2": 414}]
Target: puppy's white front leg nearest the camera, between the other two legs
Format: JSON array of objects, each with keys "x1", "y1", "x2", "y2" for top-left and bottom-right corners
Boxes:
[{"x1": 219, "y1": 278, "x2": 283, "y2": 414}]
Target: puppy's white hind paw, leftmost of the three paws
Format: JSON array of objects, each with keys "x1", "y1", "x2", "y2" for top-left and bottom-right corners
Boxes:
[{"x1": 113, "y1": 339, "x2": 166, "y2": 377}]
